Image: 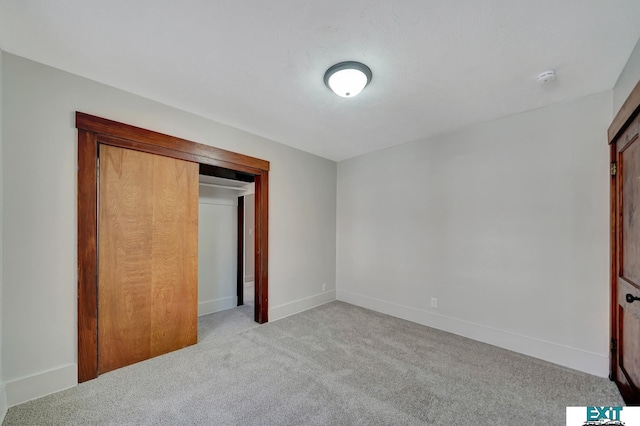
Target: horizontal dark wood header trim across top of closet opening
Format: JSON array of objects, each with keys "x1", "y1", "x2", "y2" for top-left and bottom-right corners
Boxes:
[{"x1": 76, "y1": 112, "x2": 269, "y2": 171}]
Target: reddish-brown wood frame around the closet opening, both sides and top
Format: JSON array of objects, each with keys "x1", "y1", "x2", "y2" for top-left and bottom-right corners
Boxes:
[{"x1": 76, "y1": 112, "x2": 269, "y2": 382}]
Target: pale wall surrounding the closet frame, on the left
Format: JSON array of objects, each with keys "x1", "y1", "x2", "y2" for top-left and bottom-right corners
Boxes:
[{"x1": 2, "y1": 53, "x2": 336, "y2": 405}]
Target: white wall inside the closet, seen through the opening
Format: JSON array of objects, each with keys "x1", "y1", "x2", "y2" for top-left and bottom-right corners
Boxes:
[{"x1": 198, "y1": 185, "x2": 238, "y2": 315}]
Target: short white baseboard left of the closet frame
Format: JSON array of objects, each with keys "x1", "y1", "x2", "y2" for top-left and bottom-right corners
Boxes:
[{"x1": 5, "y1": 364, "x2": 78, "y2": 407}]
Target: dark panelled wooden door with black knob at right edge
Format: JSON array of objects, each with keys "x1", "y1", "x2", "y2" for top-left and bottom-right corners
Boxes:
[{"x1": 612, "y1": 111, "x2": 640, "y2": 404}]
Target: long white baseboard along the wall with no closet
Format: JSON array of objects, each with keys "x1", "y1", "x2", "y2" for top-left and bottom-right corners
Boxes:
[{"x1": 336, "y1": 290, "x2": 609, "y2": 377}]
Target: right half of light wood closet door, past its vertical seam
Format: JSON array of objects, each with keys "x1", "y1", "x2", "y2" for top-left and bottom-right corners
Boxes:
[{"x1": 147, "y1": 154, "x2": 198, "y2": 356}]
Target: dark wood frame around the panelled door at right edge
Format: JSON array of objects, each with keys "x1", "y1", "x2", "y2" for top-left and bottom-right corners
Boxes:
[{"x1": 607, "y1": 81, "x2": 640, "y2": 381}]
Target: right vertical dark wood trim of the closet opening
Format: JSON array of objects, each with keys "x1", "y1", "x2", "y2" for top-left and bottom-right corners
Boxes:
[{"x1": 255, "y1": 171, "x2": 269, "y2": 324}]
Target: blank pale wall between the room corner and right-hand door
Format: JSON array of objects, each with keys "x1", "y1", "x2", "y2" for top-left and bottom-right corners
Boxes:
[{"x1": 337, "y1": 92, "x2": 612, "y2": 376}]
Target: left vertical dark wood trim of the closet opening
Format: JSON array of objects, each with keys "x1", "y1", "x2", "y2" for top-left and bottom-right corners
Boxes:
[{"x1": 78, "y1": 130, "x2": 98, "y2": 382}]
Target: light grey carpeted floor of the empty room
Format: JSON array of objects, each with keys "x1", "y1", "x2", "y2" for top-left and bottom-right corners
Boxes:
[{"x1": 3, "y1": 302, "x2": 623, "y2": 426}]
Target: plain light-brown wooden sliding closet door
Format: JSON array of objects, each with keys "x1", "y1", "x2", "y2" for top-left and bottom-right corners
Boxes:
[{"x1": 98, "y1": 145, "x2": 198, "y2": 373}]
